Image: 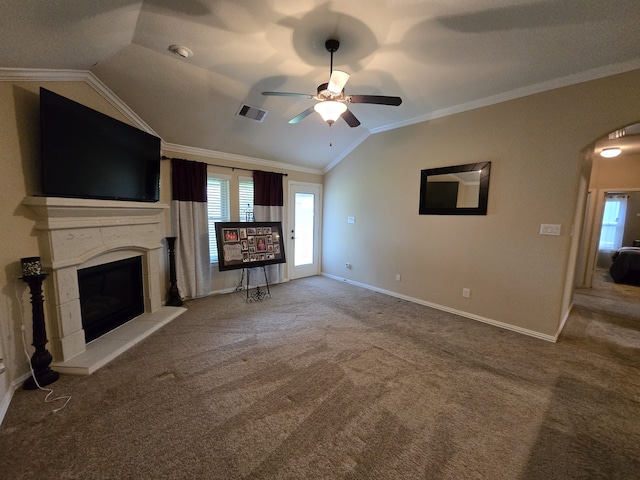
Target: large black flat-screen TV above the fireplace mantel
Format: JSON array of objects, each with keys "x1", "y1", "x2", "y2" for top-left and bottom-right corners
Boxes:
[{"x1": 40, "y1": 88, "x2": 161, "y2": 202}]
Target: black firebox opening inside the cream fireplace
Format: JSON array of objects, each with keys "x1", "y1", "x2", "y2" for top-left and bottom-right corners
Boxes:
[{"x1": 78, "y1": 256, "x2": 144, "y2": 343}]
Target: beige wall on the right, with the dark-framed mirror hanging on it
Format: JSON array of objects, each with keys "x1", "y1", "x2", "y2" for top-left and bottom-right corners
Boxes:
[{"x1": 323, "y1": 71, "x2": 640, "y2": 338}]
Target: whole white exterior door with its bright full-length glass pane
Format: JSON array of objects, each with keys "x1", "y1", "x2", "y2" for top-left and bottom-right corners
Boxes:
[{"x1": 287, "y1": 182, "x2": 322, "y2": 280}]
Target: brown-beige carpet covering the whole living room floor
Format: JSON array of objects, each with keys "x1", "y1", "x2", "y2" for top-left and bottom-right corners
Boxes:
[{"x1": 0, "y1": 277, "x2": 640, "y2": 480}]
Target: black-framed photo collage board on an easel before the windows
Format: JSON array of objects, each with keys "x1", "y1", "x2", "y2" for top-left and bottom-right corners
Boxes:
[{"x1": 216, "y1": 222, "x2": 286, "y2": 271}]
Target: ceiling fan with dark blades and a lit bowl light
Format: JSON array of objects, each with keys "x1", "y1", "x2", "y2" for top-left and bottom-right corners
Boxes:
[{"x1": 262, "y1": 38, "x2": 402, "y2": 127}]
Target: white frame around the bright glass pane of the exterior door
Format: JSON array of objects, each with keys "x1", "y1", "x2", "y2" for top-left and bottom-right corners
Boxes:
[{"x1": 287, "y1": 180, "x2": 322, "y2": 280}]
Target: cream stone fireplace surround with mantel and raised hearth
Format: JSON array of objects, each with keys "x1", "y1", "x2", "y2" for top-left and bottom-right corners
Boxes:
[{"x1": 22, "y1": 197, "x2": 185, "y2": 375}]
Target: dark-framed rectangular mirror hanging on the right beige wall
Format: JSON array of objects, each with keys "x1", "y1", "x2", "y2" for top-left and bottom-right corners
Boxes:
[{"x1": 419, "y1": 162, "x2": 491, "y2": 215}]
